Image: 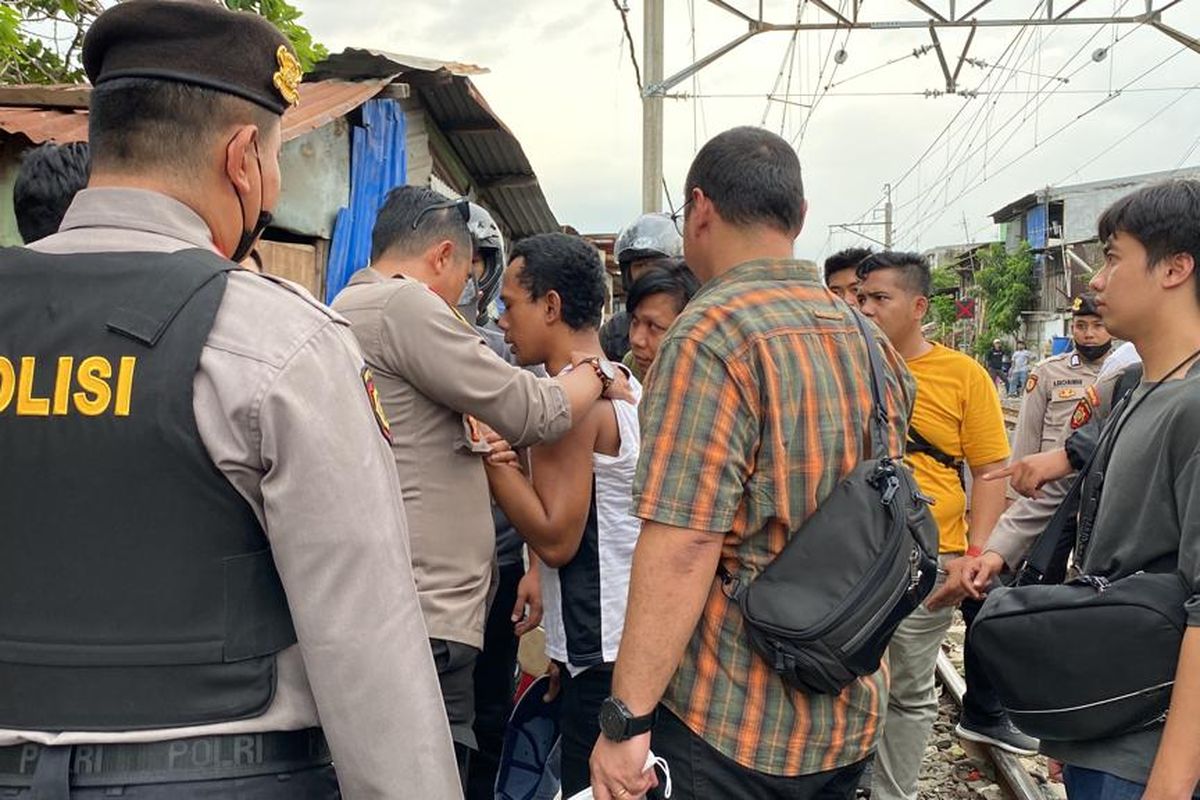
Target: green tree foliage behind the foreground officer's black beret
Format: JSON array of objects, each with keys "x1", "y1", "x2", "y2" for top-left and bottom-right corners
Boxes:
[{"x1": 0, "y1": 0, "x2": 328, "y2": 84}]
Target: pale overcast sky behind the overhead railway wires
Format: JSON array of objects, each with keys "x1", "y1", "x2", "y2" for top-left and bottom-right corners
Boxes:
[{"x1": 294, "y1": 0, "x2": 1200, "y2": 258}]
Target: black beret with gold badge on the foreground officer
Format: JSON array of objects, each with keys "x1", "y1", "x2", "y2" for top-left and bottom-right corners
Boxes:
[{"x1": 83, "y1": 0, "x2": 301, "y2": 114}]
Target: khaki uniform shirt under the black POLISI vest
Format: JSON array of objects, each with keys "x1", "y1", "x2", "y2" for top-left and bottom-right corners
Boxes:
[{"x1": 0, "y1": 188, "x2": 462, "y2": 800}]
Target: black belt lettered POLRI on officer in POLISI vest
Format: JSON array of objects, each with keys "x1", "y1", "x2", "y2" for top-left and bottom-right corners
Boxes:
[{"x1": 0, "y1": 728, "x2": 331, "y2": 787}]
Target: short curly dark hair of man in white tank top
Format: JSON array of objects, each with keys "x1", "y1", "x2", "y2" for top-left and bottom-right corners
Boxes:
[{"x1": 509, "y1": 234, "x2": 608, "y2": 331}]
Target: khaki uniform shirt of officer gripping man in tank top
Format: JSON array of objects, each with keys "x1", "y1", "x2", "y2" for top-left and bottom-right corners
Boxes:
[{"x1": 334, "y1": 267, "x2": 571, "y2": 649}]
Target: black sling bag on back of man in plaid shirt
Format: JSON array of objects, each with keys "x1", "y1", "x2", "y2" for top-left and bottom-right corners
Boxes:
[{"x1": 721, "y1": 311, "x2": 937, "y2": 694}]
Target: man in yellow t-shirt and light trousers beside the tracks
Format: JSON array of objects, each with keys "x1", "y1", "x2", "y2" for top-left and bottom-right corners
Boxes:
[{"x1": 858, "y1": 252, "x2": 1036, "y2": 800}]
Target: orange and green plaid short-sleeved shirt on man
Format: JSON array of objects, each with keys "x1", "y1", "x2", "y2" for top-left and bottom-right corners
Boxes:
[{"x1": 634, "y1": 260, "x2": 916, "y2": 775}]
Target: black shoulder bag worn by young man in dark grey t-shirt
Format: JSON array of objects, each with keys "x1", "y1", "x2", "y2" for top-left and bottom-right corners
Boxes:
[{"x1": 970, "y1": 353, "x2": 1200, "y2": 741}]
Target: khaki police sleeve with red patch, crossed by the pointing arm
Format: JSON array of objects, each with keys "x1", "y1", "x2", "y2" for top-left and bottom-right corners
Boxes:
[{"x1": 986, "y1": 369, "x2": 1123, "y2": 570}]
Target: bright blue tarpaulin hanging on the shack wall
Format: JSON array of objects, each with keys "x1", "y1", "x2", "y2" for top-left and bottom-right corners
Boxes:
[{"x1": 325, "y1": 100, "x2": 408, "y2": 302}]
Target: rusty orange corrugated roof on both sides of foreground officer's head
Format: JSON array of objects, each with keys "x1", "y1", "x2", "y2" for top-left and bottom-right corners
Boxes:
[{"x1": 0, "y1": 79, "x2": 389, "y2": 144}]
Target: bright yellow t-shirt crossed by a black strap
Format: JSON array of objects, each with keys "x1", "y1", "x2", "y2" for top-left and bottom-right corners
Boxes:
[{"x1": 906, "y1": 344, "x2": 1010, "y2": 553}]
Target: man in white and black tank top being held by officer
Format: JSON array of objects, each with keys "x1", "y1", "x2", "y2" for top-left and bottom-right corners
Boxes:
[{"x1": 487, "y1": 234, "x2": 642, "y2": 798}]
